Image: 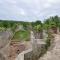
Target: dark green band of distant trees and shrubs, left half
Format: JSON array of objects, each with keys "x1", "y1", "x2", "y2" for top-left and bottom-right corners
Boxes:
[{"x1": 0, "y1": 20, "x2": 29, "y2": 31}]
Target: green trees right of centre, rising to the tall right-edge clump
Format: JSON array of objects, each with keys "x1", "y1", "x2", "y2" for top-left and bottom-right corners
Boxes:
[{"x1": 32, "y1": 16, "x2": 60, "y2": 32}]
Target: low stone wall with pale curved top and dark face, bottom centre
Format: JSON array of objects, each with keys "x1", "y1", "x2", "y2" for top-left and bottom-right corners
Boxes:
[{"x1": 15, "y1": 44, "x2": 45, "y2": 60}]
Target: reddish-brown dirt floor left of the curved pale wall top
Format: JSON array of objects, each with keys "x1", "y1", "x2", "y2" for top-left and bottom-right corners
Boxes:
[{"x1": 8, "y1": 42, "x2": 31, "y2": 60}]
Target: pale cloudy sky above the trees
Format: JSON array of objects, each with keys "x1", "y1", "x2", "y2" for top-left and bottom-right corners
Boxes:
[{"x1": 0, "y1": 0, "x2": 60, "y2": 21}]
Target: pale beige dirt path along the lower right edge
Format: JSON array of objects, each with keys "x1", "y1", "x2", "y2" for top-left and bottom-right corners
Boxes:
[{"x1": 39, "y1": 35, "x2": 60, "y2": 60}]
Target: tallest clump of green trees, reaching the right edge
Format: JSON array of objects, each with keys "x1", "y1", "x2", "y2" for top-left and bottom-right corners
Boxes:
[{"x1": 43, "y1": 16, "x2": 60, "y2": 32}]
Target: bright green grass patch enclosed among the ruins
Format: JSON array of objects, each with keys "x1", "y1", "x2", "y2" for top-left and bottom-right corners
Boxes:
[{"x1": 13, "y1": 30, "x2": 30, "y2": 41}]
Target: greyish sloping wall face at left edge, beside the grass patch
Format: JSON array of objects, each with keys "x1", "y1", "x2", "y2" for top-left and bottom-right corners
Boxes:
[{"x1": 0, "y1": 31, "x2": 10, "y2": 49}]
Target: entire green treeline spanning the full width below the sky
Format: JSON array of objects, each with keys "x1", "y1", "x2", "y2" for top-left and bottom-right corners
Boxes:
[{"x1": 0, "y1": 16, "x2": 60, "y2": 32}]
